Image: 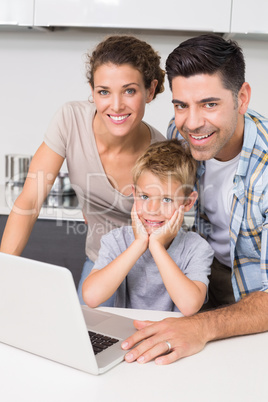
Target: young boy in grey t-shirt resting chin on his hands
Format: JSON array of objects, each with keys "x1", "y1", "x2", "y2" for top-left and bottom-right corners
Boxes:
[{"x1": 83, "y1": 140, "x2": 213, "y2": 315}]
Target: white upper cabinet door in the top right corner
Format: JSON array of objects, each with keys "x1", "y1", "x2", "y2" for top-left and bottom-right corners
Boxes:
[{"x1": 231, "y1": 0, "x2": 268, "y2": 34}]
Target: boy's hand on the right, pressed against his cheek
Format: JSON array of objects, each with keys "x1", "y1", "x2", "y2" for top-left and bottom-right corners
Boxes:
[{"x1": 149, "y1": 205, "x2": 184, "y2": 247}]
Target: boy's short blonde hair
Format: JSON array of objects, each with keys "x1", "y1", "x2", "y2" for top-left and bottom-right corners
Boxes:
[{"x1": 132, "y1": 139, "x2": 197, "y2": 197}]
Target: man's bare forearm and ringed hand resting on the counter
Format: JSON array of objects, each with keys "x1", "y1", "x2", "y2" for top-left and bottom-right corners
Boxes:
[{"x1": 122, "y1": 292, "x2": 268, "y2": 364}]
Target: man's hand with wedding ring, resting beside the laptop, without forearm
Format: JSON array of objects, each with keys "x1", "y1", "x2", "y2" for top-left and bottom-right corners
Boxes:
[{"x1": 122, "y1": 315, "x2": 207, "y2": 365}]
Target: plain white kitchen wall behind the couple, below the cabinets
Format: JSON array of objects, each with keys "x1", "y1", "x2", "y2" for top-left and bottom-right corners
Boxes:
[{"x1": 0, "y1": 28, "x2": 268, "y2": 184}]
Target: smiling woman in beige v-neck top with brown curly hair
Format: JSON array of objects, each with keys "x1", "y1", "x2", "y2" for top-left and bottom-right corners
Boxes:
[{"x1": 1, "y1": 35, "x2": 164, "y2": 305}]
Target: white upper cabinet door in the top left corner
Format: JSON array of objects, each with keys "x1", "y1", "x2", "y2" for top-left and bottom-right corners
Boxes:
[{"x1": 0, "y1": 0, "x2": 34, "y2": 26}]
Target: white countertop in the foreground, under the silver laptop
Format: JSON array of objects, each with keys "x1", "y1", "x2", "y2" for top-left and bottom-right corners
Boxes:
[{"x1": 0, "y1": 308, "x2": 268, "y2": 402}]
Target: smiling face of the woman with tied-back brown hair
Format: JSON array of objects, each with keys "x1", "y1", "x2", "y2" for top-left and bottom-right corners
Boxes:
[{"x1": 92, "y1": 63, "x2": 157, "y2": 136}]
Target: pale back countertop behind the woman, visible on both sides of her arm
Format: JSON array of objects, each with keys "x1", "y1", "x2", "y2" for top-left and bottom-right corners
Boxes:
[{"x1": 0, "y1": 184, "x2": 84, "y2": 221}]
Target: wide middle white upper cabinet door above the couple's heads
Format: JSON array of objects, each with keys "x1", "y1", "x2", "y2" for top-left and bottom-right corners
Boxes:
[{"x1": 34, "y1": 0, "x2": 232, "y2": 32}]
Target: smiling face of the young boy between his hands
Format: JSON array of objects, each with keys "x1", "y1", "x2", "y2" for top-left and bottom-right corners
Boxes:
[{"x1": 134, "y1": 171, "x2": 191, "y2": 234}]
